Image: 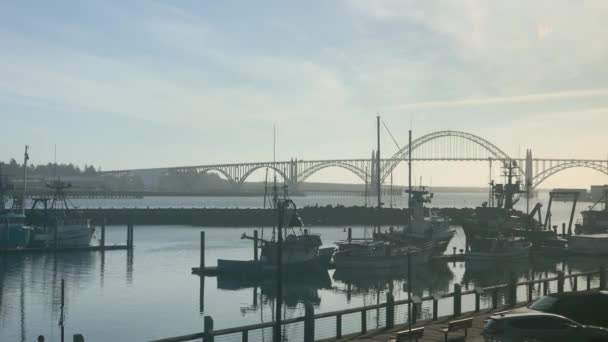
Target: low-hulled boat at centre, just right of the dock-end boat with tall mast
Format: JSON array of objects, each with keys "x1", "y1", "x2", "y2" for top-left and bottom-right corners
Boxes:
[{"x1": 334, "y1": 240, "x2": 433, "y2": 271}]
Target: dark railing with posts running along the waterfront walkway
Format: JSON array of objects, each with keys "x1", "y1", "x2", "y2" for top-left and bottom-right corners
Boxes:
[{"x1": 152, "y1": 266, "x2": 607, "y2": 342}]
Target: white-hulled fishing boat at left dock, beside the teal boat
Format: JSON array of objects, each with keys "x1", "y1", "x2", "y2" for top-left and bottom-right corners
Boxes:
[{"x1": 30, "y1": 179, "x2": 95, "y2": 247}]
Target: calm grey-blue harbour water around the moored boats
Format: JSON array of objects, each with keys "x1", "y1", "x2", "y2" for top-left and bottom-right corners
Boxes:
[{"x1": 0, "y1": 193, "x2": 606, "y2": 341}]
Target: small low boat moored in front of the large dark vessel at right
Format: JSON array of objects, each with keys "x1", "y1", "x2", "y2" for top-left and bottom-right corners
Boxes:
[{"x1": 465, "y1": 237, "x2": 532, "y2": 261}]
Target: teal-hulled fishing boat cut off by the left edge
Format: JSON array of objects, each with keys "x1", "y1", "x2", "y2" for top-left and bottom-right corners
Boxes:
[{"x1": 0, "y1": 162, "x2": 31, "y2": 249}]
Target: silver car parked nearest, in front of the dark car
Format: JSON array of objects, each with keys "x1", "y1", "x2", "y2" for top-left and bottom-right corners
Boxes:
[{"x1": 481, "y1": 310, "x2": 608, "y2": 342}]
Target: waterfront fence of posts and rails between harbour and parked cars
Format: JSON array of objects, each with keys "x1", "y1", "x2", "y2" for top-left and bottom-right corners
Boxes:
[{"x1": 152, "y1": 266, "x2": 607, "y2": 342}]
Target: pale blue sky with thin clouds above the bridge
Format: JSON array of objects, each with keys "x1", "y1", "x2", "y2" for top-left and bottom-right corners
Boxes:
[{"x1": 0, "y1": 0, "x2": 608, "y2": 186}]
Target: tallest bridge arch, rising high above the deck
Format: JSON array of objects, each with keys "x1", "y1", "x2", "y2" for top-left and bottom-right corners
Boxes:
[{"x1": 380, "y1": 131, "x2": 524, "y2": 183}]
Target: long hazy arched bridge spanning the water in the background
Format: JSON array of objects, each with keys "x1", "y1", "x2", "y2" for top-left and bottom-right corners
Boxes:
[{"x1": 102, "y1": 131, "x2": 608, "y2": 189}]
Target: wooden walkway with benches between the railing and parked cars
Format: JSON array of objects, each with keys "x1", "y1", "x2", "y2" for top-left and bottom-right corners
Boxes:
[{"x1": 337, "y1": 304, "x2": 523, "y2": 342}]
